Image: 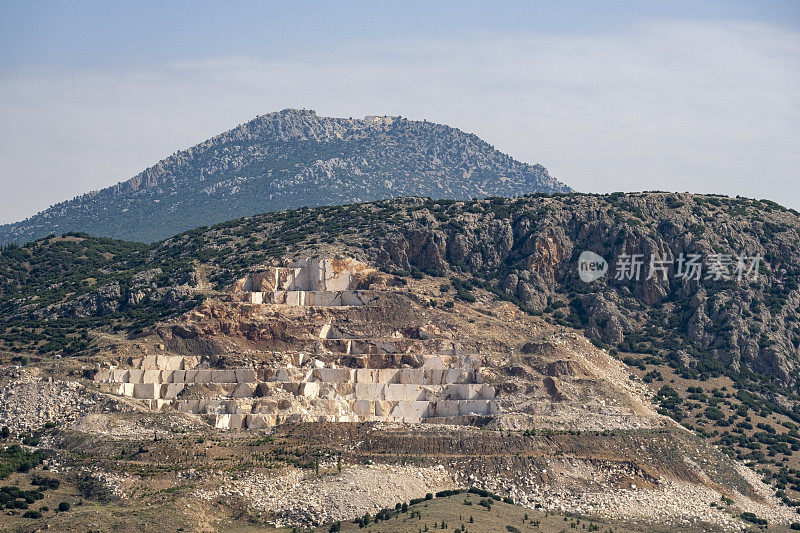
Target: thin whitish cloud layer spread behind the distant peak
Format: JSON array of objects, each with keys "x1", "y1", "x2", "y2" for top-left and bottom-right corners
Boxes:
[{"x1": 0, "y1": 20, "x2": 800, "y2": 222}]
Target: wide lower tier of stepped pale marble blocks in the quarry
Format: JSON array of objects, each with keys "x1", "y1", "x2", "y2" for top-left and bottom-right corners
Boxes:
[{"x1": 95, "y1": 354, "x2": 498, "y2": 429}]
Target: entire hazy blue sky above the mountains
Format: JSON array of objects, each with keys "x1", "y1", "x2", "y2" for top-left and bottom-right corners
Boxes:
[{"x1": 0, "y1": 0, "x2": 800, "y2": 223}]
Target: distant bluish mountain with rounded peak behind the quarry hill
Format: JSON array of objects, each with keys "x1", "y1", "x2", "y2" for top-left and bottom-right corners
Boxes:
[{"x1": 0, "y1": 109, "x2": 570, "y2": 244}]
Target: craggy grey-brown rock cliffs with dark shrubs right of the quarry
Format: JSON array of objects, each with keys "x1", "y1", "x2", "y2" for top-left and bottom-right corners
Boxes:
[{"x1": 358, "y1": 193, "x2": 800, "y2": 384}]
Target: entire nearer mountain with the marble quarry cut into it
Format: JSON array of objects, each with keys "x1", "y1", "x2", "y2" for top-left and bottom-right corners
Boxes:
[{"x1": 0, "y1": 192, "x2": 800, "y2": 531}]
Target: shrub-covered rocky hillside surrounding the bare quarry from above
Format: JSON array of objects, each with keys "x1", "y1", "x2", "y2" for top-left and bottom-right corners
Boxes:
[{"x1": 0, "y1": 193, "x2": 800, "y2": 499}]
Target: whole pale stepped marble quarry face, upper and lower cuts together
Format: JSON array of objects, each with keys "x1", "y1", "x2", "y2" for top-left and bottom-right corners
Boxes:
[{"x1": 94, "y1": 258, "x2": 506, "y2": 429}]
